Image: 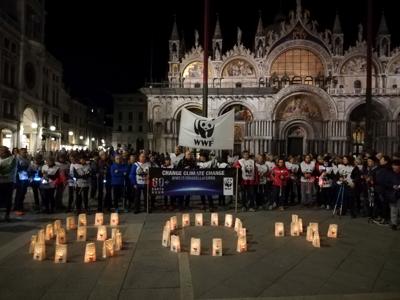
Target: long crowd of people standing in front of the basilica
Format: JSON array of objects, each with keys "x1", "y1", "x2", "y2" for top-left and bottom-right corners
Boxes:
[{"x1": 0, "y1": 146, "x2": 400, "y2": 229}]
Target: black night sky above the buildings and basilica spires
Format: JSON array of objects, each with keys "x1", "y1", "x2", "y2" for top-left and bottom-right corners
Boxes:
[{"x1": 46, "y1": 0, "x2": 400, "y2": 107}]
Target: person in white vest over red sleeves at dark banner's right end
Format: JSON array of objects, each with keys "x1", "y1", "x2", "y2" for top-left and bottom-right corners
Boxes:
[{"x1": 234, "y1": 150, "x2": 258, "y2": 212}]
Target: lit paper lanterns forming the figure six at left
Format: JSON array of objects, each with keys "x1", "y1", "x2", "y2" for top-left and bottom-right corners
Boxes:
[{"x1": 29, "y1": 213, "x2": 122, "y2": 263}]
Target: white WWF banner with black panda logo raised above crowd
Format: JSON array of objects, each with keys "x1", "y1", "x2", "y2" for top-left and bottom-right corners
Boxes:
[{"x1": 179, "y1": 108, "x2": 235, "y2": 149}]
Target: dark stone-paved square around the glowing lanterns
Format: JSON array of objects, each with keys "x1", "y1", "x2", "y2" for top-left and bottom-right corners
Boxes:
[{"x1": 0, "y1": 208, "x2": 400, "y2": 299}]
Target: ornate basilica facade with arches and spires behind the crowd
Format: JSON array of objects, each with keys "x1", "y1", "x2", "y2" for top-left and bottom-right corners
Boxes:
[{"x1": 142, "y1": 0, "x2": 400, "y2": 154}]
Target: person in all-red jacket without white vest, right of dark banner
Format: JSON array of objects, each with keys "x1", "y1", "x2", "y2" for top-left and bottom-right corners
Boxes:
[{"x1": 271, "y1": 158, "x2": 290, "y2": 210}]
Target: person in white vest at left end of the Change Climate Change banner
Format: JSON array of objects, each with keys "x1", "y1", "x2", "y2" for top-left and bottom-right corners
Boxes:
[{"x1": 129, "y1": 153, "x2": 150, "y2": 214}]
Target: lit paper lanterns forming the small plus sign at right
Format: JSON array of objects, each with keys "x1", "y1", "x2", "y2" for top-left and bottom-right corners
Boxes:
[{"x1": 275, "y1": 215, "x2": 338, "y2": 248}]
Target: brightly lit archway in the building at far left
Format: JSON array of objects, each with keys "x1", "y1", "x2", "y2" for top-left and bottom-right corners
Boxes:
[{"x1": 21, "y1": 107, "x2": 38, "y2": 152}]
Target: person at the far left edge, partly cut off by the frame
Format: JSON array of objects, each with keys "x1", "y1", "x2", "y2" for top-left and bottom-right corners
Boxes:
[{"x1": 0, "y1": 146, "x2": 17, "y2": 222}]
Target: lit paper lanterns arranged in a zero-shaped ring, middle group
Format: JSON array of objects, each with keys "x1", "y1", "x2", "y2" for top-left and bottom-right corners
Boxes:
[{"x1": 161, "y1": 213, "x2": 247, "y2": 256}]
